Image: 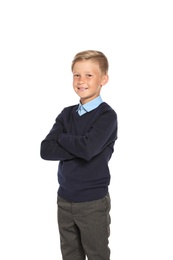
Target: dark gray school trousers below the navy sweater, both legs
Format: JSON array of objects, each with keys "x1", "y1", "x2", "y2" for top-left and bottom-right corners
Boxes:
[{"x1": 57, "y1": 194, "x2": 111, "y2": 260}]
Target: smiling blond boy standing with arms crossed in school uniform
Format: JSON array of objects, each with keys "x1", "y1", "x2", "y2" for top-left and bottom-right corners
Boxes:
[{"x1": 41, "y1": 50, "x2": 117, "y2": 260}]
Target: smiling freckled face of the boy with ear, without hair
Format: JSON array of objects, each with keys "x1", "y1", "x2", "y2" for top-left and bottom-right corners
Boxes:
[{"x1": 73, "y1": 60, "x2": 108, "y2": 104}]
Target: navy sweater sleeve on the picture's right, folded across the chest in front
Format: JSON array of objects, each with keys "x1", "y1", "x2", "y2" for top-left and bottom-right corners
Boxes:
[{"x1": 58, "y1": 110, "x2": 117, "y2": 161}]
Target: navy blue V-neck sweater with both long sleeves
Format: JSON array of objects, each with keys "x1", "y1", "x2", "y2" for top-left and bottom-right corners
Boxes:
[{"x1": 41, "y1": 102, "x2": 117, "y2": 202}]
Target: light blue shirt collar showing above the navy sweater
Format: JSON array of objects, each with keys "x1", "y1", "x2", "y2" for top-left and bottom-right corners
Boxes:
[{"x1": 77, "y1": 96, "x2": 103, "y2": 116}]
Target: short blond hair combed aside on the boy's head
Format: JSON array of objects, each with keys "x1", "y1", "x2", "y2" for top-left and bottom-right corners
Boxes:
[{"x1": 71, "y1": 50, "x2": 109, "y2": 74}]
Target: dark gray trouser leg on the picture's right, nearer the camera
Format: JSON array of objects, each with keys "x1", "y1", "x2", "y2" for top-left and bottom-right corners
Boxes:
[{"x1": 73, "y1": 194, "x2": 111, "y2": 260}]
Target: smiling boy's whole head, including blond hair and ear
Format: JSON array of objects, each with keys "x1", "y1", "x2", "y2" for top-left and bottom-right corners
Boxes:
[{"x1": 71, "y1": 50, "x2": 108, "y2": 104}]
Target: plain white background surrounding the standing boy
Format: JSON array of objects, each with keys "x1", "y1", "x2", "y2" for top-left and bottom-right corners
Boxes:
[{"x1": 0, "y1": 0, "x2": 173, "y2": 260}]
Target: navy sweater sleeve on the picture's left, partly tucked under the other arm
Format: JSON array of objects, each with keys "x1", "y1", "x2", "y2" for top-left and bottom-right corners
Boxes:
[{"x1": 40, "y1": 114, "x2": 76, "y2": 161}]
